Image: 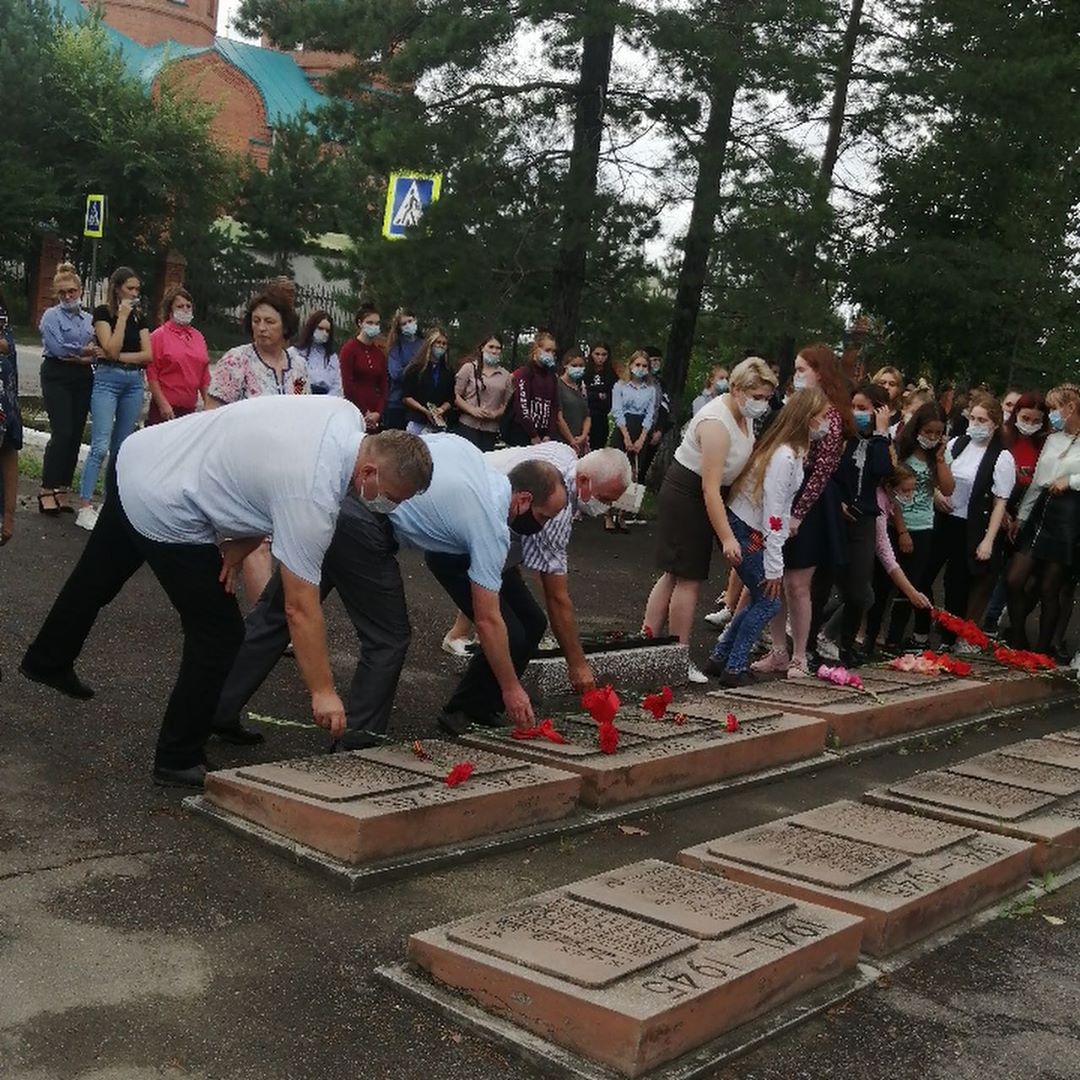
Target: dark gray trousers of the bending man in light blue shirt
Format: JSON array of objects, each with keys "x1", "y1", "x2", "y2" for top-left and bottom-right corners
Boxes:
[{"x1": 214, "y1": 495, "x2": 411, "y2": 748}]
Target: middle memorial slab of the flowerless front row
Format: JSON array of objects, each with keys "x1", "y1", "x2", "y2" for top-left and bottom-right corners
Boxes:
[{"x1": 678, "y1": 801, "x2": 1035, "y2": 956}]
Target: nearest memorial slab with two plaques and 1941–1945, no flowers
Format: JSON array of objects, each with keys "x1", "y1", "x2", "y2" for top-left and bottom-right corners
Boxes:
[{"x1": 408, "y1": 860, "x2": 862, "y2": 1077}]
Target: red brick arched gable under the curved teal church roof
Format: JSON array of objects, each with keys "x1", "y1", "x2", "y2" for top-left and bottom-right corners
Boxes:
[{"x1": 162, "y1": 53, "x2": 271, "y2": 168}]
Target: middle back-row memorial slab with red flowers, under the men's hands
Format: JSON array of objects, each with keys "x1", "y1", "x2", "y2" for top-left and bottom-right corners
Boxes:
[{"x1": 461, "y1": 694, "x2": 825, "y2": 808}]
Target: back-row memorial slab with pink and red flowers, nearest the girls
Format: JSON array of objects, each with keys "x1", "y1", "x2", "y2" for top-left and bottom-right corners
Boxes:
[{"x1": 712, "y1": 662, "x2": 1076, "y2": 746}]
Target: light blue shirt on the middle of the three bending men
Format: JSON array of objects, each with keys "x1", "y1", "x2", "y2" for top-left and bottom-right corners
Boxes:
[{"x1": 387, "y1": 434, "x2": 510, "y2": 593}]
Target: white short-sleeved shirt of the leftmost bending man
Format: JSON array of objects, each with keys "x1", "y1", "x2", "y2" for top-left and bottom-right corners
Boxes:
[{"x1": 117, "y1": 395, "x2": 364, "y2": 584}]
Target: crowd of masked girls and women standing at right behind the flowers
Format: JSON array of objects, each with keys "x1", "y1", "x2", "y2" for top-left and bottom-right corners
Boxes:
[{"x1": 644, "y1": 342, "x2": 1080, "y2": 687}]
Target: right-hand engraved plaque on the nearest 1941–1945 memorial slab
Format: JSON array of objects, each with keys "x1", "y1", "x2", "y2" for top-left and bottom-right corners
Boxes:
[{"x1": 567, "y1": 861, "x2": 795, "y2": 937}]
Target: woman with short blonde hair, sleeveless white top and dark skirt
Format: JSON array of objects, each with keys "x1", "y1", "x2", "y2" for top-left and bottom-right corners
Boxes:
[{"x1": 645, "y1": 356, "x2": 777, "y2": 683}]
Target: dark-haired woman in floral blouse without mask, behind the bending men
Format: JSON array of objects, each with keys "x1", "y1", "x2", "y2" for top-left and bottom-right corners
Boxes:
[{"x1": 206, "y1": 288, "x2": 311, "y2": 604}]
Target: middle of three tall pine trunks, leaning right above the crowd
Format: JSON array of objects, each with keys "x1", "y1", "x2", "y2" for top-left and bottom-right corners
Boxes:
[{"x1": 664, "y1": 71, "x2": 739, "y2": 418}]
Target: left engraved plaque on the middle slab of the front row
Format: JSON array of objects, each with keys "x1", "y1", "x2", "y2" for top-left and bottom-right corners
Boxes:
[{"x1": 708, "y1": 822, "x2": 909, "y2": 889}]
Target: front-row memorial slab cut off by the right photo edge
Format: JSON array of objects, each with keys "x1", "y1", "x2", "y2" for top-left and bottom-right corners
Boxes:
[{"x1": 865, "y1": 735, "x2": 1080, "y2": 874}]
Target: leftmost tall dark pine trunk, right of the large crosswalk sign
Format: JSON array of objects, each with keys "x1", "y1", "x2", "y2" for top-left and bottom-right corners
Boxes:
[{"x1": 549, "y1": 27, "x2": 615, "y2": 350}]
